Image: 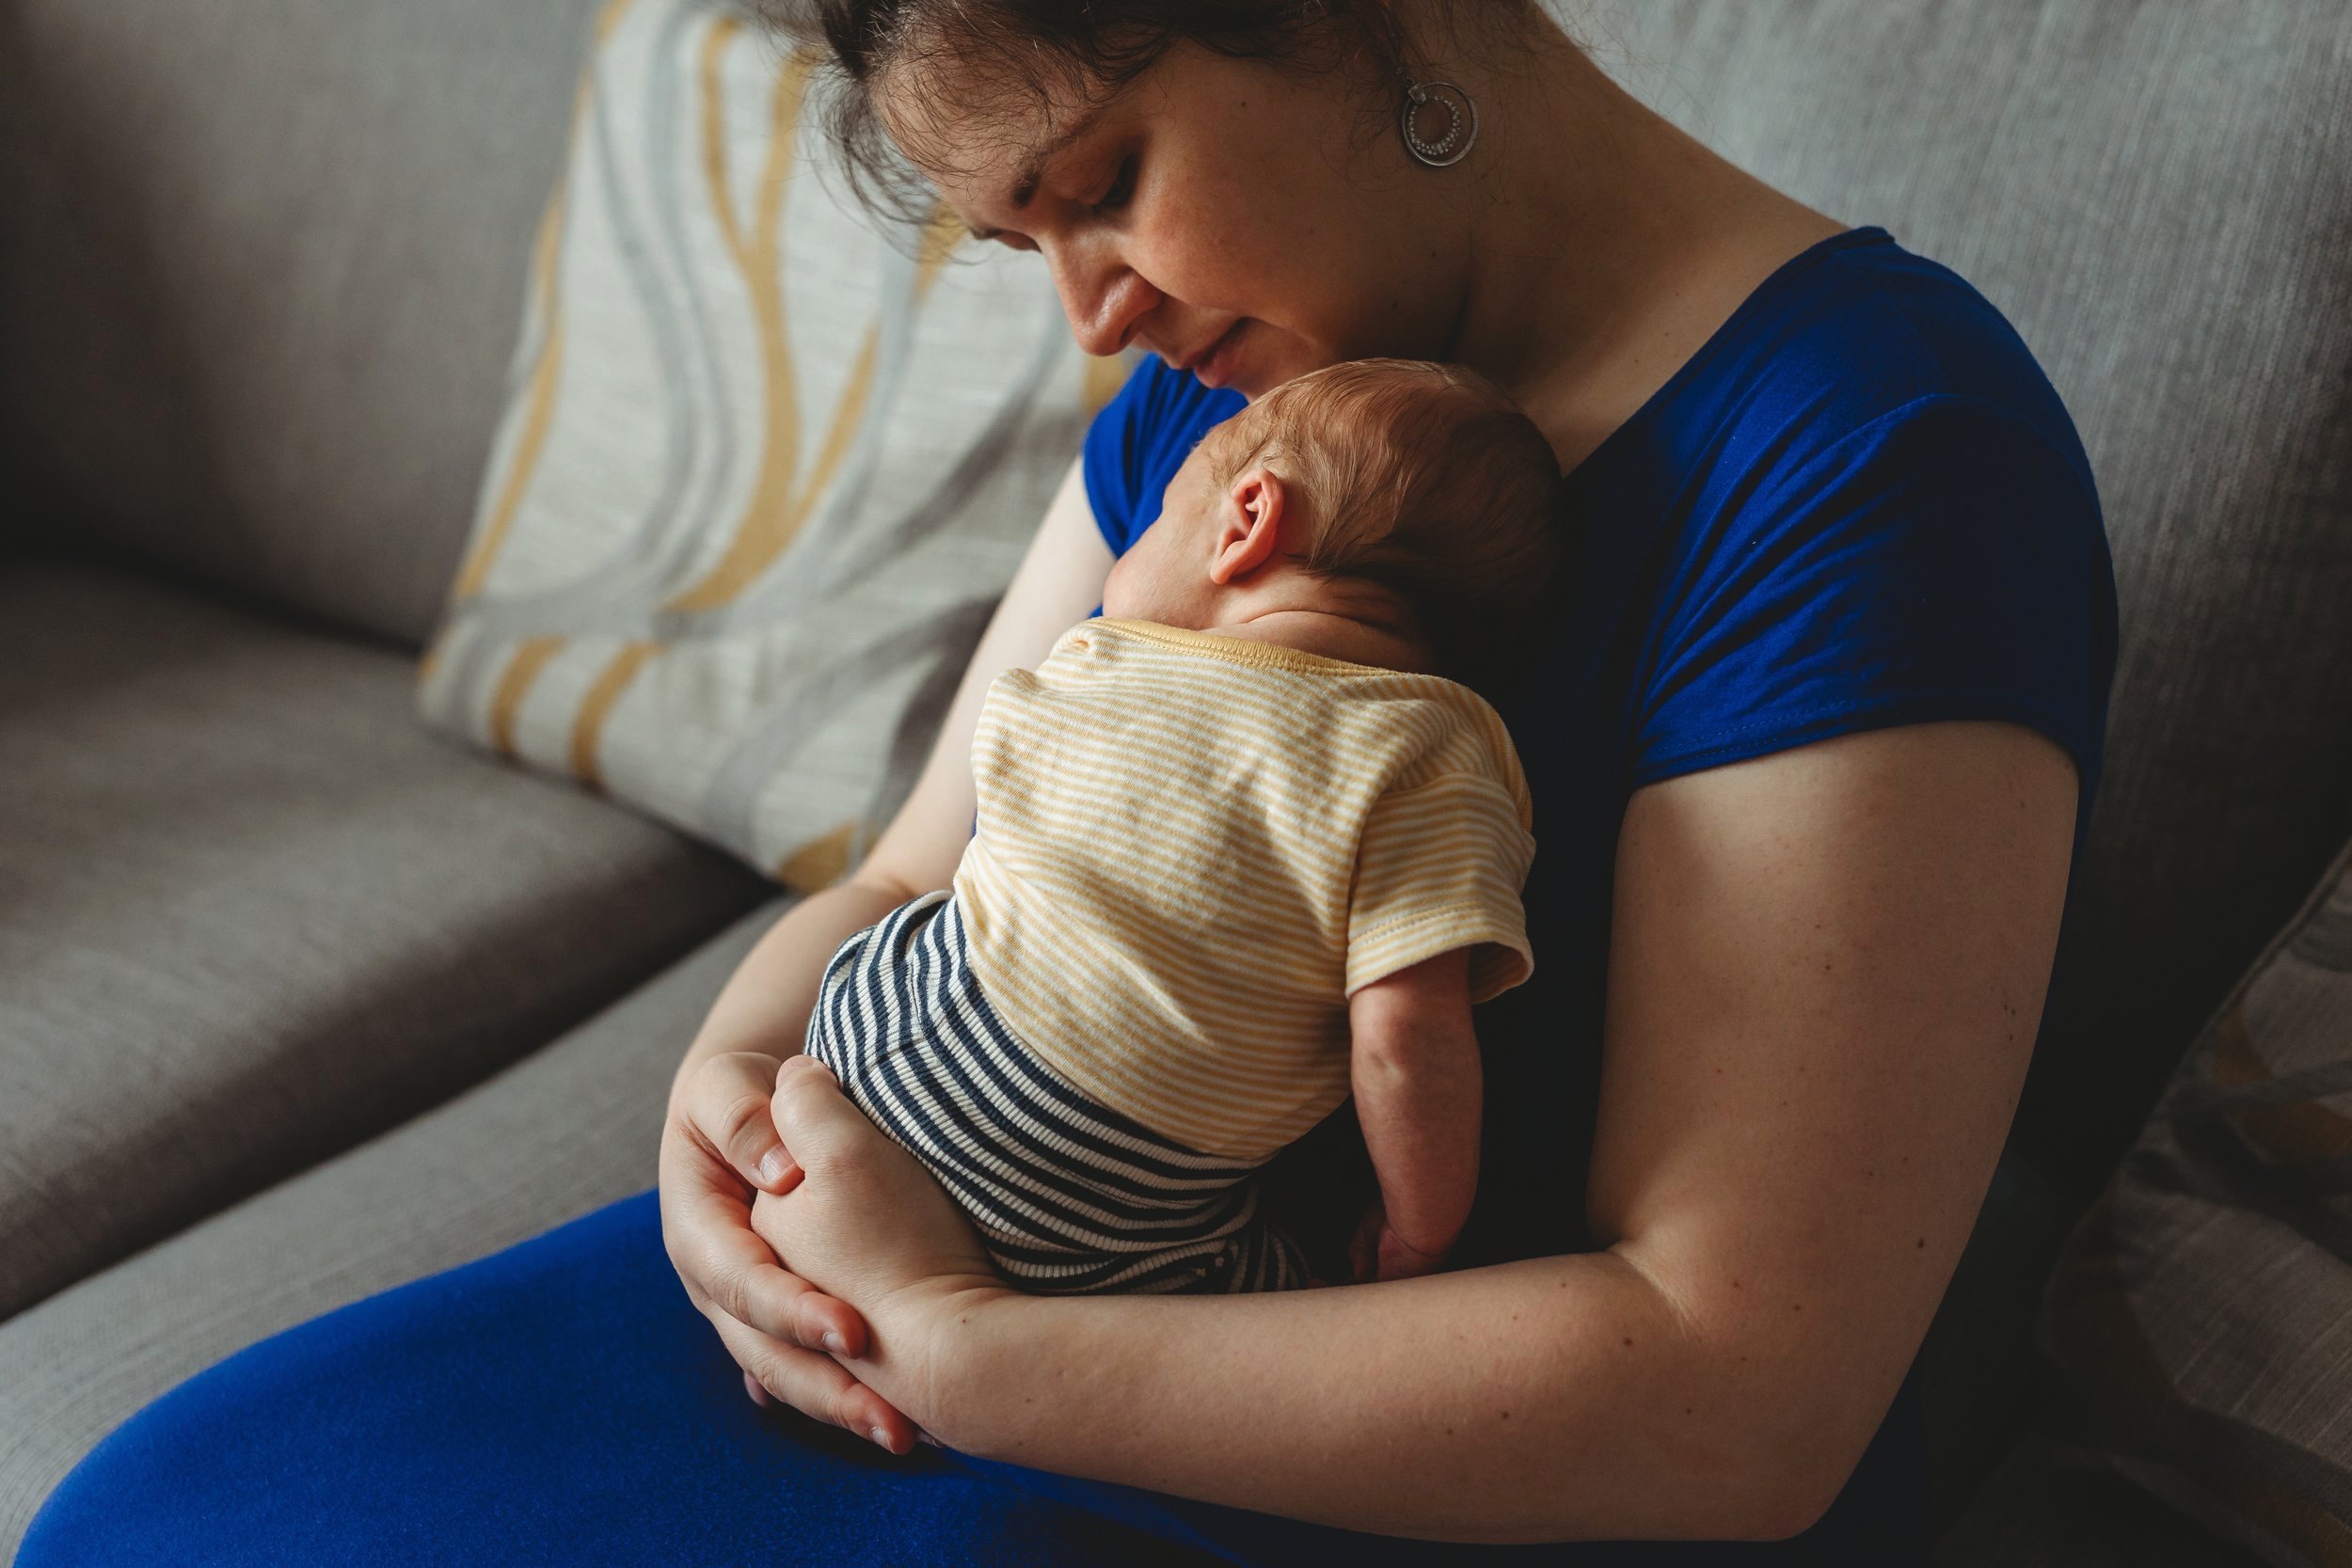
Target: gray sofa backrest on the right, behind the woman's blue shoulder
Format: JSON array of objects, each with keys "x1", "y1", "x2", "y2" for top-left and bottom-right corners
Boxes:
[{"x1": 1560, "y1": 0, "x2": 2352, "y2": 1196}]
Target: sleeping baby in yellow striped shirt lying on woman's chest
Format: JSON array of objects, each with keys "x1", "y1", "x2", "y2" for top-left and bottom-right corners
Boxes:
[{"x1": 807, "y1": 359, "x2": 1560, "y2": 1293}]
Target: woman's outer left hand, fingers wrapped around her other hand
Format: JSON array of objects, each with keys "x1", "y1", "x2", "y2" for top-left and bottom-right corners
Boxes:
[{"x1": 659, "y1": 1051, "x2": 915, "y2": 1453}]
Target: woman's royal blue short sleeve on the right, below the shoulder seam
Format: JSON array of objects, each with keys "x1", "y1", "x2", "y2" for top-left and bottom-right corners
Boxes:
[{"x1": 1632, "y1": 395, "x2": 2112, "y2": 785}]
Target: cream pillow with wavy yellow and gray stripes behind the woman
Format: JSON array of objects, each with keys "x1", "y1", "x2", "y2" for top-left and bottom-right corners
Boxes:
[{"x1": 419, "y1": 0, "x2": 1127, "y2": 891}]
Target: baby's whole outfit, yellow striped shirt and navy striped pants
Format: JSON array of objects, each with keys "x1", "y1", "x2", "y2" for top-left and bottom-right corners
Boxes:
[{"x1": 807, "y1": 618, "x2": 1536, "y2": 1293}]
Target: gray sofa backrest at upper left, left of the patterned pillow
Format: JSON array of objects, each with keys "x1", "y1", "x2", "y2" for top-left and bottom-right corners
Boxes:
[{"x1": 0, "y1": 0, "x2": 593, "y2": 646}]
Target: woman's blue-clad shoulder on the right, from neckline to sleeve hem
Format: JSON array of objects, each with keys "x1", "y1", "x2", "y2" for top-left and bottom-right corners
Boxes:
[{"x1": 1618, "y1": 230, "x2": 2117, "y2": 816}]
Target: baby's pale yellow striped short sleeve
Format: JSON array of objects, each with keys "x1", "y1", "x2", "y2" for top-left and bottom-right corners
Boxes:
[{"x1": 1348, "y1": 771, "x2": 1536, "y2": 1002}]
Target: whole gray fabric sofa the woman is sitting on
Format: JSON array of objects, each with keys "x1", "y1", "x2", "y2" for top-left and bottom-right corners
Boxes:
[{"x1": 0, "y1": 0, "x2": 2352, "y2": 1566}]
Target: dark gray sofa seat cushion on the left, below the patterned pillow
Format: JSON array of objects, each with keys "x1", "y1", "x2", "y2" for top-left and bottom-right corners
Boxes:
[{"x1": 0, "y1": 560, "x2": 776, "y2": 1317}]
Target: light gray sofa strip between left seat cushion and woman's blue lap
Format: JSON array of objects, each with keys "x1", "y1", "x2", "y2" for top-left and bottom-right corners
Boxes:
[{"x1": 0, "y1": 898, "x2": 790, "y2": 1561}]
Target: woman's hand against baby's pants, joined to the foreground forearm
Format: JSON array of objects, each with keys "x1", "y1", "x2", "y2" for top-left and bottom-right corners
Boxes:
[{"x1": 751, "y1": 1055, "x2": 1007, "y2": 1453}]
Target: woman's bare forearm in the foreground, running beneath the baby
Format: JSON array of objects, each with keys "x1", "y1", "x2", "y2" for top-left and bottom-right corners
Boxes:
[{"x1": 911, "y1": 1253, "x2": 1819, "y2": 1543}]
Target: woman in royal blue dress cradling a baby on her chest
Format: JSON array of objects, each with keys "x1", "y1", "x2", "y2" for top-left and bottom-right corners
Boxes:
[{"x1": 22, "y1": 0, "x2": 2115, "y2": 1568}]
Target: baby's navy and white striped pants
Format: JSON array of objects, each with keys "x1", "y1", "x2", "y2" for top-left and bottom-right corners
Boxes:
[{"x1": 807, "y1": 891, "x2": 1308, "y2": 1293}]
